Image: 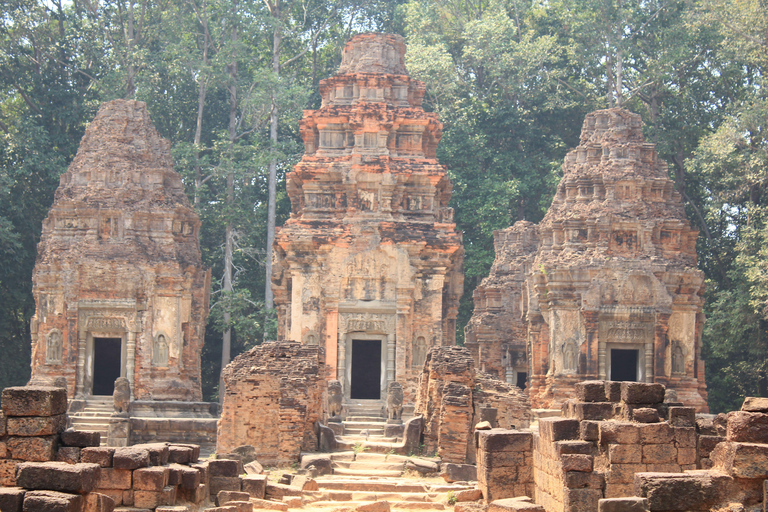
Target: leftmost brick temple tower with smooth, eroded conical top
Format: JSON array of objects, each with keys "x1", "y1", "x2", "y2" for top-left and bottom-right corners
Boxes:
[{"x1": 32, "y1": 100, "x2": 210, "y2": 400}]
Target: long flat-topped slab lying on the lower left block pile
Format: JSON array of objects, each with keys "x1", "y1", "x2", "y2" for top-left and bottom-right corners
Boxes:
[{"x1": 16, "y1": 462, "x2": 101, "y2": 494}]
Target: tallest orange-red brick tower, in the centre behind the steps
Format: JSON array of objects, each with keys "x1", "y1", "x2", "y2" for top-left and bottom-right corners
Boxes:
[{"x1": 272, "y1": 34, "x2": 463, "y2": 399}]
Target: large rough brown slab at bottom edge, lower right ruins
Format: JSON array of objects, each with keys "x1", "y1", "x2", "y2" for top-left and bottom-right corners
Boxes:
[{"x1": 634, "y1": 471, "x2": 731, "y2": 511}]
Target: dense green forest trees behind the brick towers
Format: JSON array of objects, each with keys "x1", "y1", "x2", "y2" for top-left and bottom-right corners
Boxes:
[{"x1": 0, "y1": 0, "x2": 768, "y2": 411}]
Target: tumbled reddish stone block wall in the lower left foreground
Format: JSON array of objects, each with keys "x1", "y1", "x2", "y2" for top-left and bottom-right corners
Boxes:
[{"x1": 0, "y1": 386, "x2": 264, "y2": 512}]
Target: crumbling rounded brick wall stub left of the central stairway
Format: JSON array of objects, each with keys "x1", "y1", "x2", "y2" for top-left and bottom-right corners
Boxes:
[{"x1": 216, "y1": 341, "x2": 327, "y2": 465}]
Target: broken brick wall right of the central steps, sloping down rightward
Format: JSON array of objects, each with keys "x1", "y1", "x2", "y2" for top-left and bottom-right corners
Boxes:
[{"x1": 415, "y1": 347, "x2": 530, "y2": 464}]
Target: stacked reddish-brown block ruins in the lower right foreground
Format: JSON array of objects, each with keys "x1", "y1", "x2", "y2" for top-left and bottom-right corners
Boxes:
[{"x1": 477, "y1": 381, "x2": 744, "y2": 512}]
